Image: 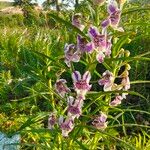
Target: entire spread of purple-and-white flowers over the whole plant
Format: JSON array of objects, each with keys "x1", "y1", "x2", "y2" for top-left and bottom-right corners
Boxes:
[{"x1": 48, "y1": 0, "x2": 130, "y2": 137}]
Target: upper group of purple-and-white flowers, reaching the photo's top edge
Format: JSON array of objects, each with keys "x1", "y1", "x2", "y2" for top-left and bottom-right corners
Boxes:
[{"x1": 65, "y1": 0, "x2": 123, "y2": 67}]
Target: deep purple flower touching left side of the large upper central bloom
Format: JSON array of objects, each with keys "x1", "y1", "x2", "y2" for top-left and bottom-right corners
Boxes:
[{"x1": 77, "y1": 35, "x2": 94, "y2": 53}]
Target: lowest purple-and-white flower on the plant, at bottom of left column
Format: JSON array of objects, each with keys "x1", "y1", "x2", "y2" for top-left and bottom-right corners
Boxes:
[{"x1": 59, "y1": 117, "x2": 74, "y2": 137}]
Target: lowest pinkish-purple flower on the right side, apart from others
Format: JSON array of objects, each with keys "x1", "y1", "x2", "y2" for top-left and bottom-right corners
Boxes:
[{"x1": 92, "y1": 113, "x2": 107, "y2": 130}]
